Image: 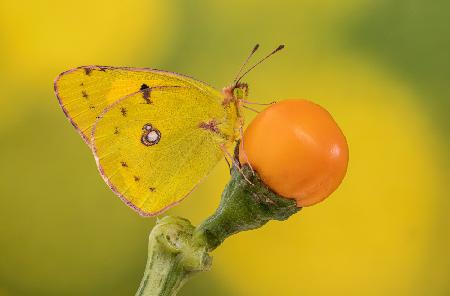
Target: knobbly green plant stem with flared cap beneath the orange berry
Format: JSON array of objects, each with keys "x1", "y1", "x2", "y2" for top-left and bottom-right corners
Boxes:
[{"x1": 136, "y1": 166, "x2": 300, "y2": 296}]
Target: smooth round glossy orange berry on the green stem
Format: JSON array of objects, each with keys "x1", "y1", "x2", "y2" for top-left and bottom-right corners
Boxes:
[{"x1": 239, "y1": 100, "x2": 348, "y2": 207}]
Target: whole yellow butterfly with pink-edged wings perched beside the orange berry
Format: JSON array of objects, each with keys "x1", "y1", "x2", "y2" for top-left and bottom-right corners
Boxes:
[{"x1": 54, "y1": 45, "x2": 284, "y2": 216}]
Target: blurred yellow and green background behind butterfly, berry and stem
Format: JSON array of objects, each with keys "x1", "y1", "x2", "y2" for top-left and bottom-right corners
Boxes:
[{"x1": 0, "y1": 0, "x2": 450, "y2": 296}]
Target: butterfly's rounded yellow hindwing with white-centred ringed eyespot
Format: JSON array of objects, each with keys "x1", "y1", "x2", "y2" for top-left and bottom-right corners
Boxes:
[{"x1": 92, "y1": 85, "x2": 236, "y2": 216}]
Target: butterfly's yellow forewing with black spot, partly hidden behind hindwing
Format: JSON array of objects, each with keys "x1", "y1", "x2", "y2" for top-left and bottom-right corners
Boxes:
[{"x1": 54, "y1": 66, "x2": 219, "y2": 146}]
